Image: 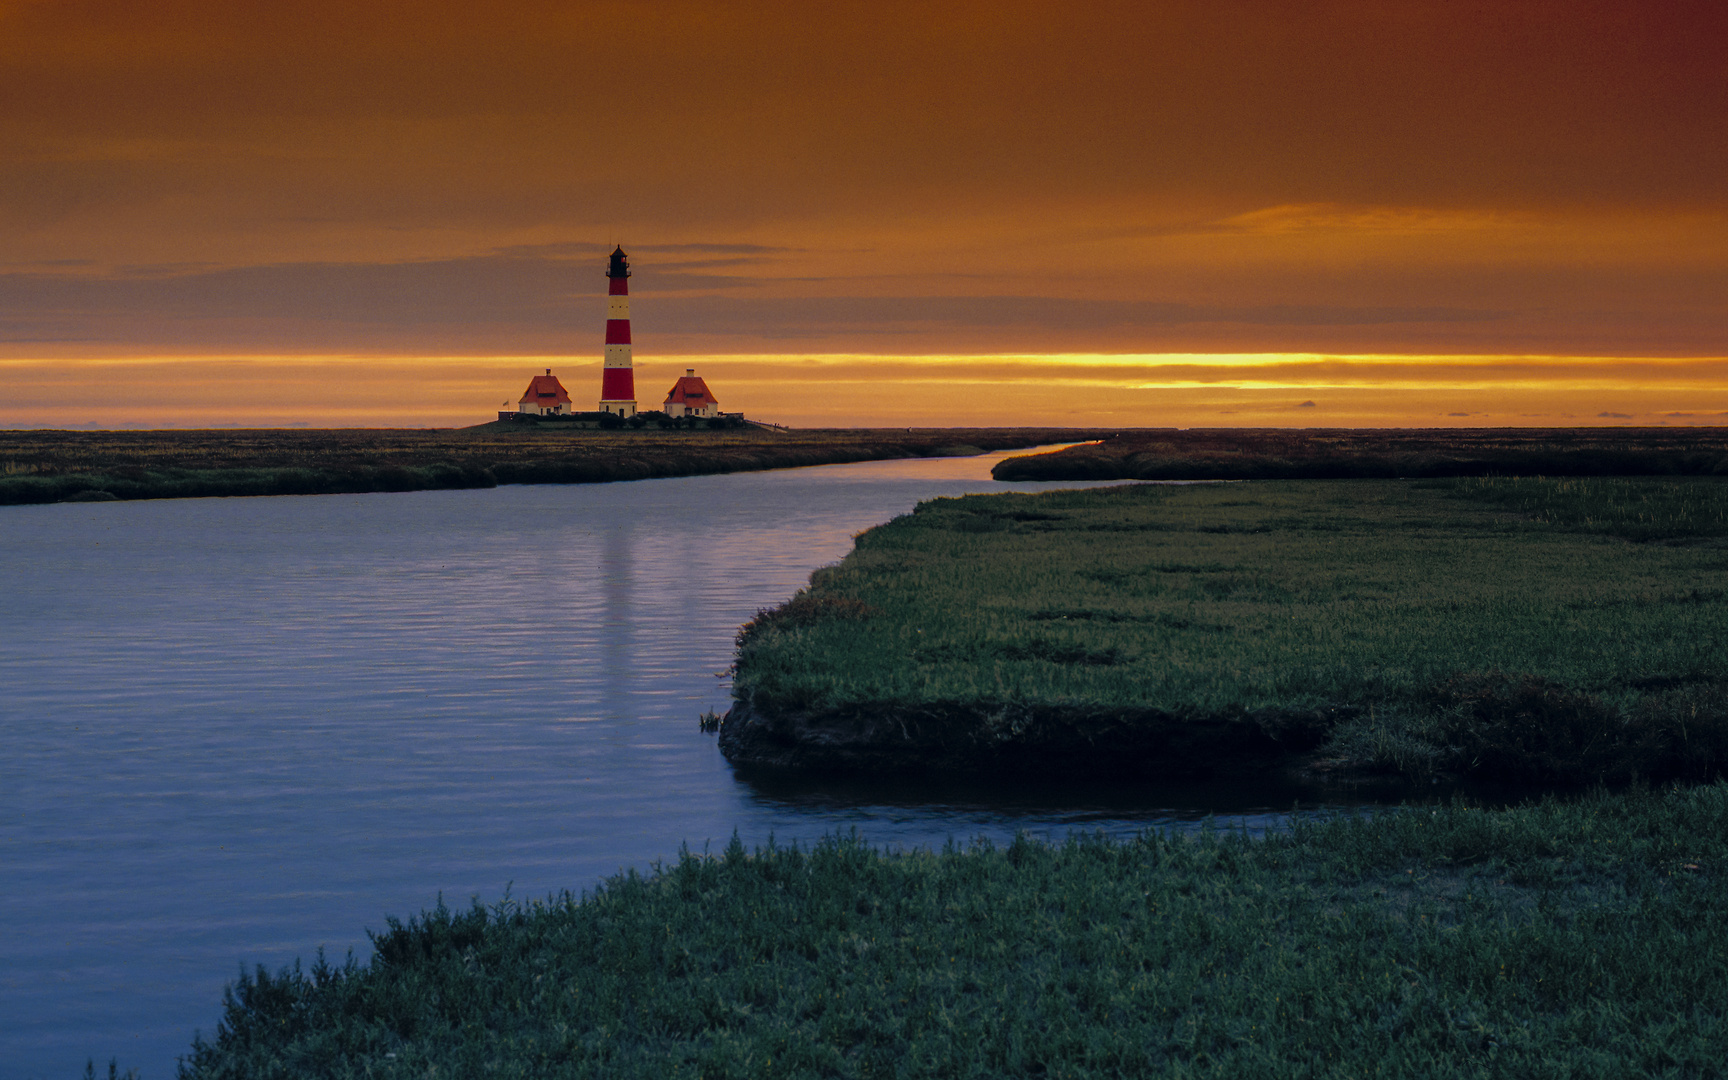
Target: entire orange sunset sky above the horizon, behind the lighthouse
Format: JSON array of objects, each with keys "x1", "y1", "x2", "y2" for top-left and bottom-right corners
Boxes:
[{"x1": 0, "y1": 0, "x2": 1728, "y2": 427}]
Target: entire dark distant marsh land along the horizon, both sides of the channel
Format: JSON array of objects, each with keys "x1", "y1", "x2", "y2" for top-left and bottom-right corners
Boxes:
[{"x1": 13, "y1": 422, "x2": 1728, "y2": 505}]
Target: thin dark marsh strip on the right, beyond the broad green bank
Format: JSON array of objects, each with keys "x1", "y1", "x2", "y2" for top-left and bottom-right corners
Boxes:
[{"x1": 995, "y1": 427, "x2": 1728, "y2": 480}]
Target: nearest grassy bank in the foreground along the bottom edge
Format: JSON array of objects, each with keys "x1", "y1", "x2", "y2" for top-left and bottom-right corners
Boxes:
[{"x1": 180, "y1": 785, "x2": 1728, "y2": 1080}]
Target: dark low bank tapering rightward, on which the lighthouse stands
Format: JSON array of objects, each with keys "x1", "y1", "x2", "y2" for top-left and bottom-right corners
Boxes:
[{"x1": 0, "y1": 423, "x2": 1096, "y2": 505}]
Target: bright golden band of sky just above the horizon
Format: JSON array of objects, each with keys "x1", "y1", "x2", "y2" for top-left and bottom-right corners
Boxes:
[{"x1": 0, "y1": 353, "x2": 1728, "y2": 427}]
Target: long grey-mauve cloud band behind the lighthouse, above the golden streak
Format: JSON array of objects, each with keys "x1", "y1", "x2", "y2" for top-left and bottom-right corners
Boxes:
[{"x1": 13, "y1": 244, "x2": 1728, "y2": 354}]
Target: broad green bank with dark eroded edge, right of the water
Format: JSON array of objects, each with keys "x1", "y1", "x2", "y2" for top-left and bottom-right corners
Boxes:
[{"x1": 721, "y1": 479, "x2": 1728, "y2": 783}]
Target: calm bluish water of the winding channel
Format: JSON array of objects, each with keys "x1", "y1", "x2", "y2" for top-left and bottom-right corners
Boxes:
[{"x1": 0, "y1": 454, "x2": 1361, "y2": 1078}]
